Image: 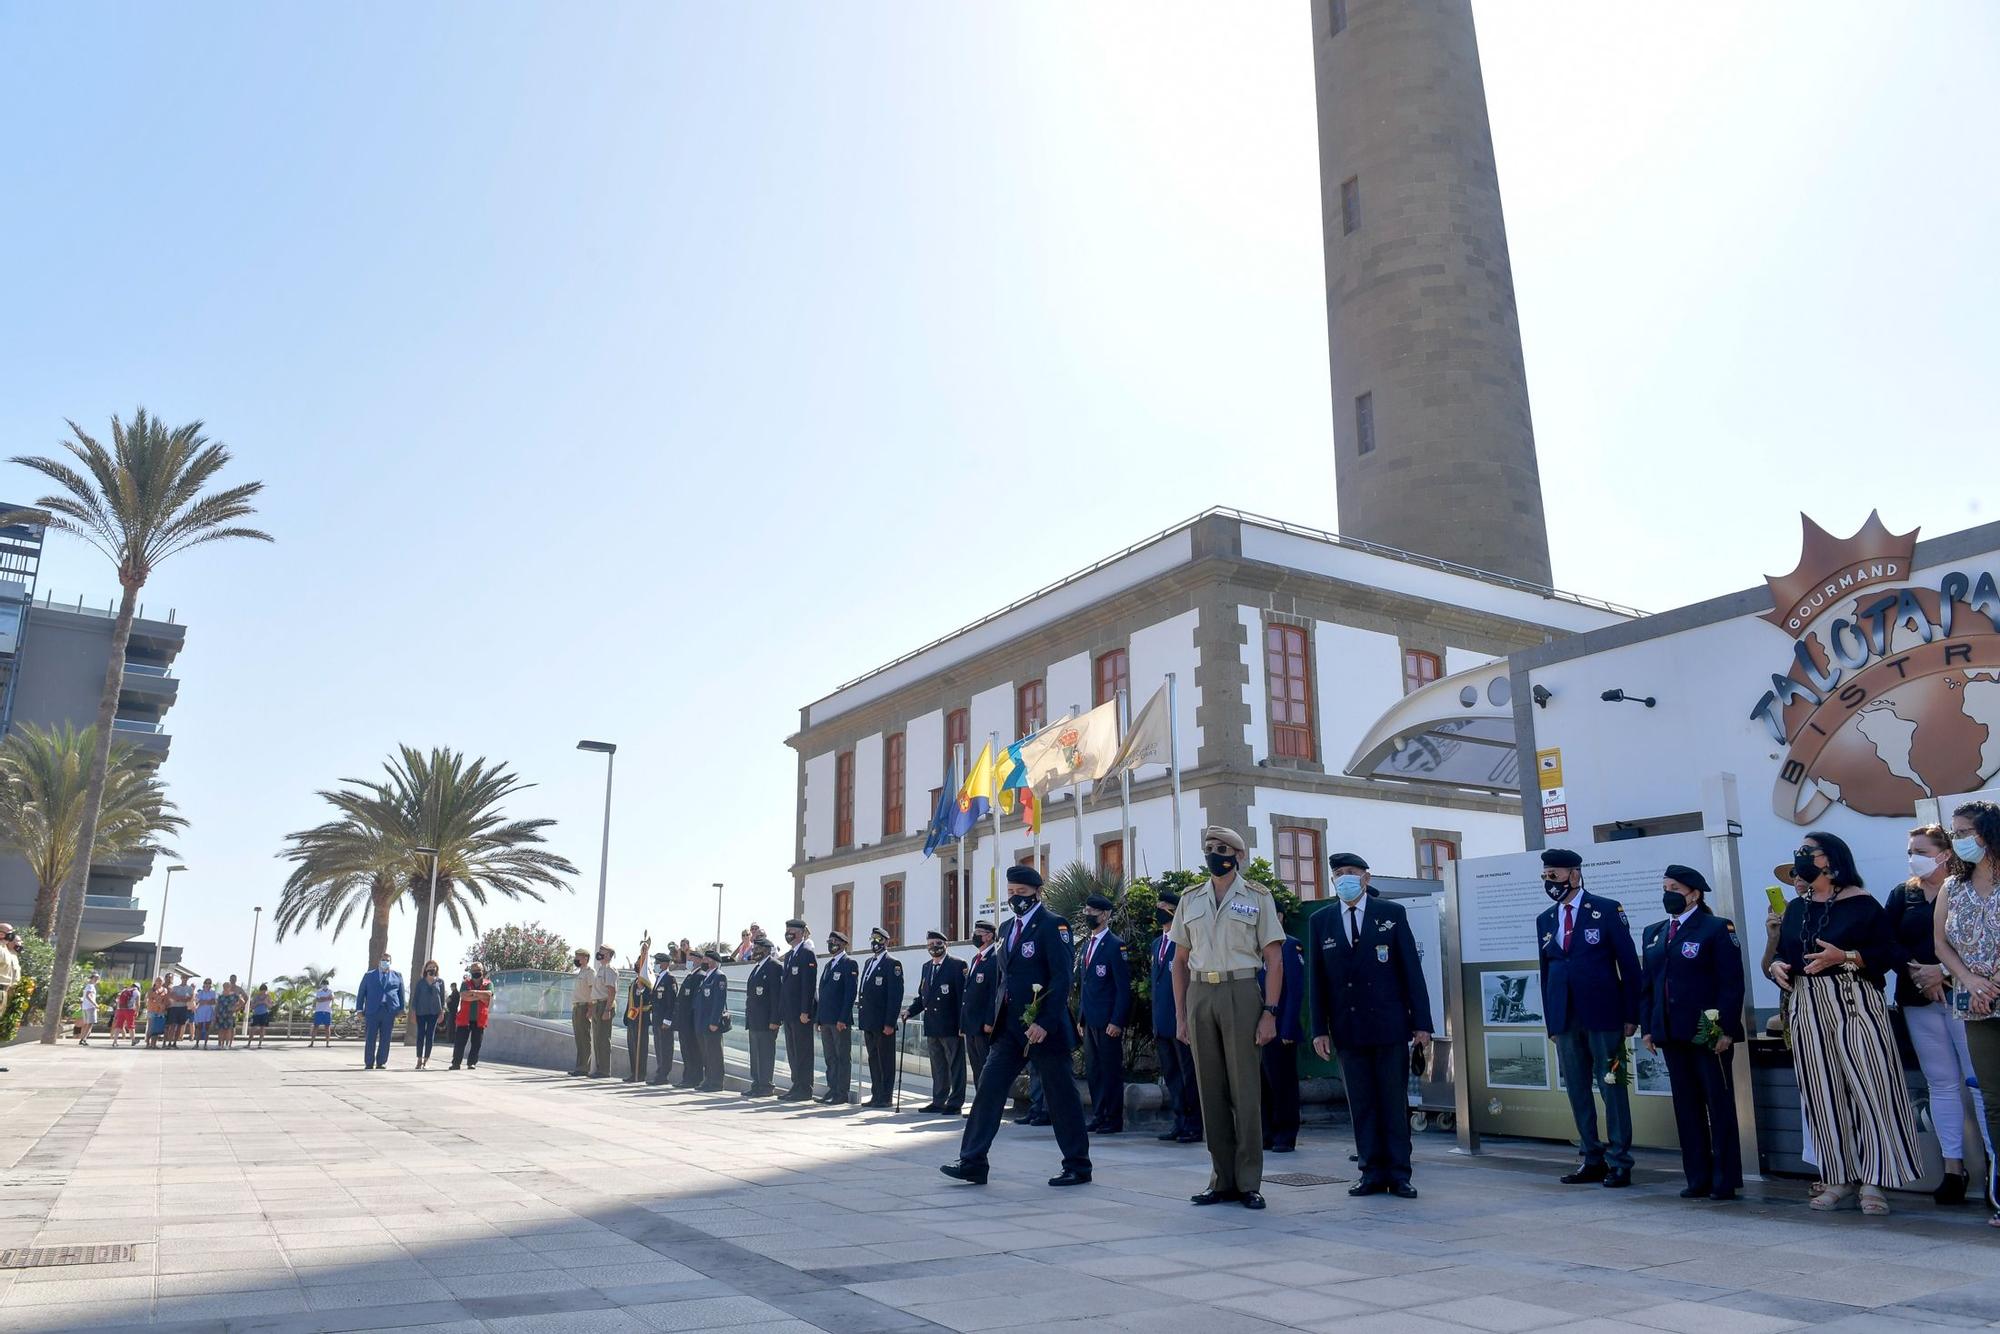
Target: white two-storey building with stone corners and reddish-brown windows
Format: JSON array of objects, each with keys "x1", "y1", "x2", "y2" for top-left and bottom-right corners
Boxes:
[{"x1": 788, "y1": 510, "x2": 1636, "y2": 942}]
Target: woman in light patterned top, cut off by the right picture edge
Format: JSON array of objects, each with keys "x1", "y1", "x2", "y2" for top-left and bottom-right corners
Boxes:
[{"x1": 1932, "y1": 802, "x2": 2000, "y2": 1228}]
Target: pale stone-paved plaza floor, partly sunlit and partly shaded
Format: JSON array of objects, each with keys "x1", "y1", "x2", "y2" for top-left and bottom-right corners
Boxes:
[{"x1": 0, "y1": 1046, "x2": 2000, "y2": 1334}]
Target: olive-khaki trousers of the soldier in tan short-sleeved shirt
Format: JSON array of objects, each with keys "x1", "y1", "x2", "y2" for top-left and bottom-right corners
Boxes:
[{"x1": 1188, "y1": 978, "x2": 1264, "y2": 1192}]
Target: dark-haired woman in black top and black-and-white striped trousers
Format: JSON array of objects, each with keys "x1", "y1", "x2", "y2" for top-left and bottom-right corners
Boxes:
[{"x1": 1770, "y1": 830, "x2": 1922, "y2": 1216}]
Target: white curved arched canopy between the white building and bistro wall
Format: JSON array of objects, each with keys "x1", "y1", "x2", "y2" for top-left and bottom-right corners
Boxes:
[{"x1": 1346, "y1": 658, "x2": 1520, "y2": 794}]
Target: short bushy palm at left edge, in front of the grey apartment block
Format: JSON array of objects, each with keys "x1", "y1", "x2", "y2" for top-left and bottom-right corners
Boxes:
[{"x1": 0, "y1": 722, "x2": 188, "y2": 938}]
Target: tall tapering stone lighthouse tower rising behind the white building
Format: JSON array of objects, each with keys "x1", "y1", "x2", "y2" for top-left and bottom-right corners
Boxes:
[{"x1": 1312, "y1": 0, "x2": 1550, "y2": 584}]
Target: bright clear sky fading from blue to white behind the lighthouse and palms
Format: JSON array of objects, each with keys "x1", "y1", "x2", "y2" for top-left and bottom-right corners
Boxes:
[{"x1": 0, "y1": 0, "x2": 2000, "y2": 976}]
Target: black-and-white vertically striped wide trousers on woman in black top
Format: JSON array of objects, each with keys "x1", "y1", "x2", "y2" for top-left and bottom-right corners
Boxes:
[{"x1": 1790, "y1": 968, "x2": 1922, "y2": 1190}]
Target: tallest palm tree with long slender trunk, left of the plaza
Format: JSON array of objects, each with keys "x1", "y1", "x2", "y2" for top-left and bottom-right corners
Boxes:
[{"x1": 0, "y1": 408, "x2": 270, "y2": 1044}]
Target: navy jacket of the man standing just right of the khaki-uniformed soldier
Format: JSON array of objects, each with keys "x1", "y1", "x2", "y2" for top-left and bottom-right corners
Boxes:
[{"x1": 1306, "y1": 892, "x2": 1430, "y2": 1048}]
